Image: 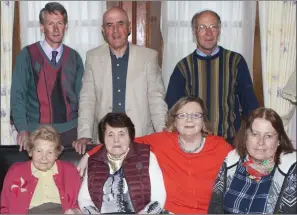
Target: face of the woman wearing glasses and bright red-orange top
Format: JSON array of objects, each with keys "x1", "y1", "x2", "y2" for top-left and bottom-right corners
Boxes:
[{"x1": 174, "y1": 102, "x2": 204, "y2": 136}]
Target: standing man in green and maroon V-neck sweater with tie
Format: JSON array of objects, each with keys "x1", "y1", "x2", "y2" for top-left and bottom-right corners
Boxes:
[{"x1": 11, "y1": 2, "x2": 84, "y2": 151}]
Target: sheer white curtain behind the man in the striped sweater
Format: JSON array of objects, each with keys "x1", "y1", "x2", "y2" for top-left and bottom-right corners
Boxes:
[{"x1": 161, "y1": 1, "x2": 256, "y2": 86}]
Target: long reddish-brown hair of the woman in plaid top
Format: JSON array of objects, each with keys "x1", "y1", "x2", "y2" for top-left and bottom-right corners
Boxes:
[{"x1": 234, "y1": 107, "x2": 294, "y2": 164}]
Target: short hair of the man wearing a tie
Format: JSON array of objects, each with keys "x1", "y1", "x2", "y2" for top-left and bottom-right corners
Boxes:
[{"x1": 39, "y1": 2, "x2": 68, "y2": 25}]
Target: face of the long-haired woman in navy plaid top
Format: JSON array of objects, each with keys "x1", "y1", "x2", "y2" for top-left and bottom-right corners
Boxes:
[{"x1": 246, "y1": 118, "x2": 279, "y2": 161}]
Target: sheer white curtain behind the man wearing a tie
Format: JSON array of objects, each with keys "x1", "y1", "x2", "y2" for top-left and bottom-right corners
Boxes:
[{"x1": 20, "y1": 1, "x2": 106, "y2": 63}]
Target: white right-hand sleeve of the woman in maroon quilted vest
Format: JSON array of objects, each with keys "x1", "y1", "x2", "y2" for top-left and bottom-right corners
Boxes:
[{"x1": 140, "y1": 152, "x2": 166, "y2": 214}]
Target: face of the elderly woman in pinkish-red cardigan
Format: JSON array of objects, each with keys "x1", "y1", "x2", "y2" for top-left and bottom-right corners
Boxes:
[{"x1": 29, "y1": 139, "x2": 58, "y2": 171}]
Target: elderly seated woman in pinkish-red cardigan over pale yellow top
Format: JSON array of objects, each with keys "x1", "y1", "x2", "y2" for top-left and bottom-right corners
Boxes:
[{"x1": 0, "y1": 126, "x2": 81, "y2": 214}]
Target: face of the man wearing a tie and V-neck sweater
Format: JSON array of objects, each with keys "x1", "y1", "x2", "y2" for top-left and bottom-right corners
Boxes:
[{"x1": 40, "y1": 11, "x2": 68, "y2": 48}]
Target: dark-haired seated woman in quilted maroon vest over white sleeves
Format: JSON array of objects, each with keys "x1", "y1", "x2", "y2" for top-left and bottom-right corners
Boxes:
[{"x1": 78, "y1": 113, "x2": 166, "y2": 214}]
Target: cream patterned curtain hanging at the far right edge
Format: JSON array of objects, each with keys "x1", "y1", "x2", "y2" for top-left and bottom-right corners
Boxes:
[{"x1": 259, "y1": 1, "x2": 296, "y2": 147}]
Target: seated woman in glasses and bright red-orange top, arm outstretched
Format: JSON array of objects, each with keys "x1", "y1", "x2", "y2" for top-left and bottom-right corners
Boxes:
[{"x1": 74, "y1": 96, "x2": 232, "y2": 214}]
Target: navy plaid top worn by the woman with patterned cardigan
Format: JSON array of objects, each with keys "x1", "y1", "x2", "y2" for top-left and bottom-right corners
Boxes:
[{"x1": 224, "y1": 161, "x2": 275, "y2": 214}]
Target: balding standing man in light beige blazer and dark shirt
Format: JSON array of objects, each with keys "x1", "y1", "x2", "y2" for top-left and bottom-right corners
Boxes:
[{"x1": 73, "y1": 7, "x2": 168, "y2": 154}]
